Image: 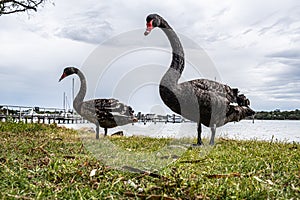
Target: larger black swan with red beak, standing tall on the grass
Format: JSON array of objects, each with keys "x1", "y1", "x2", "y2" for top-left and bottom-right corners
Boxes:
[{"x1": 144, "y1": 14, "x2": 255, "y2": 145}]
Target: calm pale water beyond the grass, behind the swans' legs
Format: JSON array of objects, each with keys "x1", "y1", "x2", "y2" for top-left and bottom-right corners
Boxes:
[{"x1": 65, "y1": 120, "x2": 300, "y2": 142}]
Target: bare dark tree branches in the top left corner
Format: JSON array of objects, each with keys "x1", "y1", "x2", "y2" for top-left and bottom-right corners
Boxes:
[{"x1": 0, "y1": 0, "x2": 48, "y2": 15}]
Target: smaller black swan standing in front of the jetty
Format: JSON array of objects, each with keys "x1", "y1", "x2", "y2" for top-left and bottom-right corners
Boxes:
[{"x1": 59, "y1": 67, "x2": 137, "y2": 139}]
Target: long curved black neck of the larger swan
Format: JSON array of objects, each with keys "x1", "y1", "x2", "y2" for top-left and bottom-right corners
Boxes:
[{"x1": 160, "y1": 19, "x2": 184, "y2": 86}]
